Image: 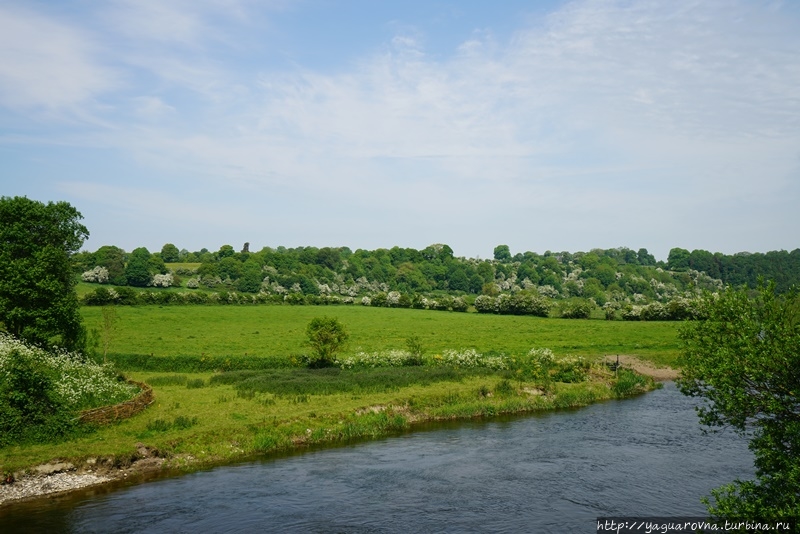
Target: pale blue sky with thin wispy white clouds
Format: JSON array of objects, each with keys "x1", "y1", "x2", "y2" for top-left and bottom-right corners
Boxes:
[{"x1": 0, "y1": 0, "x2": 800, "y2": 260}]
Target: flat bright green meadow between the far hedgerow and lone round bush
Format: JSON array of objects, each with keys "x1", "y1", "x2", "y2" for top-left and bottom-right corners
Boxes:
[{"x1": 81, "y1": 306, "x2": 679, "y2": 365}]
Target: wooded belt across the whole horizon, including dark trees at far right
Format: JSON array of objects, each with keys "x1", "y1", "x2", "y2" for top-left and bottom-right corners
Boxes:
[{"x1": 73, "y1": 243, "x2": 800, "y2": 318}]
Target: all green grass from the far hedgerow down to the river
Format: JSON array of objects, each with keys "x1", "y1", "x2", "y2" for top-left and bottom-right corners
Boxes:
[{"x1": 0, "y1": 306, "x2": 679, "y2": 482}]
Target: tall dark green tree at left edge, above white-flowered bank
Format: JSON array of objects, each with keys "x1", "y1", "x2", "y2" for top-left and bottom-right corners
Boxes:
[{"x1": 0, "y1": 197, "x2": 89, "y2": 350}]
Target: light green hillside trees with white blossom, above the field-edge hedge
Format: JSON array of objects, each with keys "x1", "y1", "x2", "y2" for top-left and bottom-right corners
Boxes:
[{"x1": 74, "y1": 244, "x2": 719, "y2": 305}]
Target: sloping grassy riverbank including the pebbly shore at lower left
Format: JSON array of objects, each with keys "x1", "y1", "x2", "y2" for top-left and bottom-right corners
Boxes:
[{"x1": 0, "y1": 362, "x2": 674, "y2": 506}]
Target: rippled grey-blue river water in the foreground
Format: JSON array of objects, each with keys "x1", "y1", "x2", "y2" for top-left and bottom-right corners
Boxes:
[{"x1": 0, "y1": 383, "x2": 753, "y2": 533}]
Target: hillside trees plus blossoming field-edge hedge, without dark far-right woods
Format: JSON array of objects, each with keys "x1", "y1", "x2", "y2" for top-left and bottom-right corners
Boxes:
[{"x1": 76, "y1": 243, "x2": 736, "y2": 320}]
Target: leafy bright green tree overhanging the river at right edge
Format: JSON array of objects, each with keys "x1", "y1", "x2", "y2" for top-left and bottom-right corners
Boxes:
[{"x1": 678, "y1": 284, "x2": 800, "y2": 518}]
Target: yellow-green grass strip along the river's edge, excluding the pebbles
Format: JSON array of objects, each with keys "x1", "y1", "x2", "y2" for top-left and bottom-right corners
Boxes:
[{"x1": 0, "y1": 368, "x2": 653, "y2": 478}]
